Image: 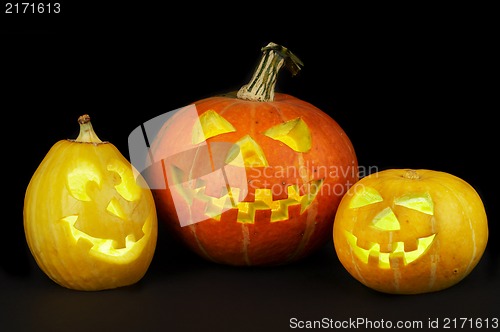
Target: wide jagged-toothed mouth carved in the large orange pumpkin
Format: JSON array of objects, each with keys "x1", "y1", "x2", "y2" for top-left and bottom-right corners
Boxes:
[{"x1": 178, "y1": 180, "x2": 323, "y2": 223}]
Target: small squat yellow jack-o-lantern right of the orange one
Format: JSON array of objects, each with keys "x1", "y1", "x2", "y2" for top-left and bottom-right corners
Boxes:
[{"x1": 333, "y1": 169, "x2": 488, "y2": 294}]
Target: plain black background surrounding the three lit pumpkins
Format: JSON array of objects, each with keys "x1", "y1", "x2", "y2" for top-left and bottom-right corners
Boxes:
[{"x1": 0, "y1": 1, "x2": 500, "y2": 332}]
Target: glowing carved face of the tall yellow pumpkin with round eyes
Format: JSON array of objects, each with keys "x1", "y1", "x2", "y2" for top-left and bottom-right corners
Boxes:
[{"x1": 59, "y1": 156, "x2": 154, "y2": 264}]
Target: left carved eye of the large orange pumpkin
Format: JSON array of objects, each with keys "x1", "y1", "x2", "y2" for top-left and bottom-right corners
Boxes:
[{"x1": 192, "y1": 110, "x2": 236, "y2": 144}]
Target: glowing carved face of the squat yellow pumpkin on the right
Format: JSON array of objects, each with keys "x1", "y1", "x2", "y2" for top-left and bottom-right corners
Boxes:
[{"x1": 345, "y1": 187, "x2": 436, "y2": 269}]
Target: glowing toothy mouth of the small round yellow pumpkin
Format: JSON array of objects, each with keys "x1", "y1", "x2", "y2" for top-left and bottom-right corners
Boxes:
[{"x1": 345, "y1": 231, "x2": 436, "y2": 269}]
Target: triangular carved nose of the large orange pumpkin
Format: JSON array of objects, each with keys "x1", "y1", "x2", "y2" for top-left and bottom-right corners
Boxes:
[{"x1": 226, "y1": 135, "x2": 269, "y2": 167}]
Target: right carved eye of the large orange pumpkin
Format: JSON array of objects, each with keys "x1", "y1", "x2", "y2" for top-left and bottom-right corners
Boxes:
[{"x1": 263, "y1": 118, "x2": 312, "y2": 152}]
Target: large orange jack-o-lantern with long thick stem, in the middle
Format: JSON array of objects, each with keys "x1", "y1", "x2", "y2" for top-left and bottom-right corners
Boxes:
[{"x1": 149, "y1": 43, "x2": 358, "y2": 266}]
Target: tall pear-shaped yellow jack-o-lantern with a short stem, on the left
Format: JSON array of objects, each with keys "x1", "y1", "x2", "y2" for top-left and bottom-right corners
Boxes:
[{"x1": 24, "y1": 115, "x2": 158, "y2": 291}]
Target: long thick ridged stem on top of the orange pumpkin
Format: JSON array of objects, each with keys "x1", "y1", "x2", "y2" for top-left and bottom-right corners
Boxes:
[{"x1": 237, "y1": 42, "x2": 304, "y2": 101}]
